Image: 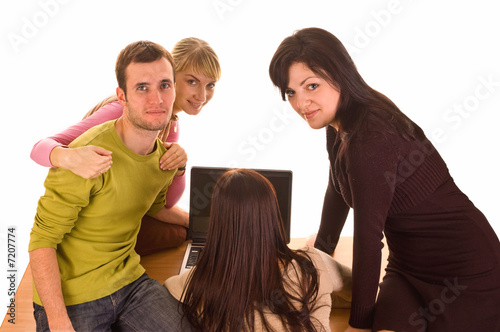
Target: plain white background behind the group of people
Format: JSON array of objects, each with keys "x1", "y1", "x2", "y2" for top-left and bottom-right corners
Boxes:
[{"x1": 0, "y1": 0, "x2": 500, "y2": 312}]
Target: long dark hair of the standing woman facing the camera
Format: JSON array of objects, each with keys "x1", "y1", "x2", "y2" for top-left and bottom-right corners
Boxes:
[{"x1": 269, "y1": 28, "x2": 424, "y2": 147}]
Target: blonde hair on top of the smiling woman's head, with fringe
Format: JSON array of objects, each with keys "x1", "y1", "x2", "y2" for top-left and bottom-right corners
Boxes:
[{"x1": 172, "y1": 37, "x2": 221, "y2": 81}]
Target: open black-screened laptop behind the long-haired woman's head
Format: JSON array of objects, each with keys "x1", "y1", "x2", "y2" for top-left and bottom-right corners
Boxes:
[{"x1": 179, "y1": 166, "x2": 292, "y2": 274}]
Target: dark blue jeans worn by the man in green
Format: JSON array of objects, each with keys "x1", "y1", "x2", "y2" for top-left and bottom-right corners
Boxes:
[{"x1": 33, "y1": 274, "x2": 191, "y2": 332}]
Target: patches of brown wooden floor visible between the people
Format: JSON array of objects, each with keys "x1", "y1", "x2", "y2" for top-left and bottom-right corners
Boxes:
[{"x1": 0, "y1": 237, "x2": 387, "y2": 332}]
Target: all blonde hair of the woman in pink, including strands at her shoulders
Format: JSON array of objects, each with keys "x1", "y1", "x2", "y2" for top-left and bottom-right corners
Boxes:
[{"x1": 83, "y1": 37, "x2": 221, "y2": 142}]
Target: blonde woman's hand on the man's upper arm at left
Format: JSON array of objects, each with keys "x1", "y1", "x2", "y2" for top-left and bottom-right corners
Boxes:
[{"x1": 50, "y1": 145, "x2": 113, "y2": 179}]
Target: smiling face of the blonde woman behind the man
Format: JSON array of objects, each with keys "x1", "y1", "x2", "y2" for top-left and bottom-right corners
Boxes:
[{"x1": 173, "y1": 69, "x2": 217, "y2": 115}]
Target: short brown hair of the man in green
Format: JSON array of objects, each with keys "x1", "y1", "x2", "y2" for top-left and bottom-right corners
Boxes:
[{"x1": 115, "y1": 40, "x2": 175, "y2": 94}]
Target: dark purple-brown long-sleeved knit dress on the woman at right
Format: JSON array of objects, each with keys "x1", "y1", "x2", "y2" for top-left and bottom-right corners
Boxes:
[{"x1": 315, "y1": 126, "x2": 500, "y2": 331}]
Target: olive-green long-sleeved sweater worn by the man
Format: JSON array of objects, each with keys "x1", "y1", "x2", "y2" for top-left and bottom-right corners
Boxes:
[{"x1": 29, "y1": 120, "x2": 176, "y2": 305}]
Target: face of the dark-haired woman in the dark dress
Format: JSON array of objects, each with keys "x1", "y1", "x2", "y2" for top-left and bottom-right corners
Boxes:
[{"x1": 286, "y1": 62, "x2": 340, "y2": 129}]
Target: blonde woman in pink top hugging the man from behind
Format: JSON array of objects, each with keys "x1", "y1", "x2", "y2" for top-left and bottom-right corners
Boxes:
[{"x1": 31, "y1": 38, "x2": 221, "y2": 255}]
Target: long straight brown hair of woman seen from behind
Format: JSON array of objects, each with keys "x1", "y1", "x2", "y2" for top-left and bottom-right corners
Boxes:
[{"x1": 183, "y1": 169, "x2": 319, "y2": 332}]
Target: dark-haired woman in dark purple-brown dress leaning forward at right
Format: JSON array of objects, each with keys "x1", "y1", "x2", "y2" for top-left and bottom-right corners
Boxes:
[{"x1": 269, "y1": 28, "x2": 500, "y2": 332}]
